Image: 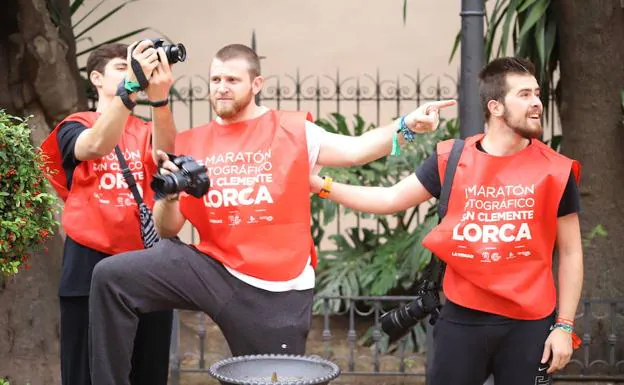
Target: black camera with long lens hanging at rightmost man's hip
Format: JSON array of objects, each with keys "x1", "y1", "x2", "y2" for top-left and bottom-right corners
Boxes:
[{"x1": 380, "y1": 283, "x2": 441, "y2": 343}]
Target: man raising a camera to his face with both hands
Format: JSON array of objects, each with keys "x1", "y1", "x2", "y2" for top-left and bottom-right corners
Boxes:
[{"x1": 41, "y1": 40, "x2": 175, "y2": 385}]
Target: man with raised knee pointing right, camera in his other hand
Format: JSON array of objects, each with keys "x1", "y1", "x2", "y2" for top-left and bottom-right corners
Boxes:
[{"x1": 86, "y1": 44, "x2": 455, "y2": 385}]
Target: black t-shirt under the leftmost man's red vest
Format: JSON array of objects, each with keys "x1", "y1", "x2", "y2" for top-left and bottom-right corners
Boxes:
[{"x1": 56, "y1": 122, "x2": 109, "y2": 297}]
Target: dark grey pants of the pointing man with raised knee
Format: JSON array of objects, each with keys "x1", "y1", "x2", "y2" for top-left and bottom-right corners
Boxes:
[{"x1": 90, "y1": 239, "x2": 313, "y2": 385}]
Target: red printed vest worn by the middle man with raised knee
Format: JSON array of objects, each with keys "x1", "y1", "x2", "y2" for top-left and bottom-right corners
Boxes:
[{"x1": 176, "y1": 110, "x2": 316, "y2": 281}]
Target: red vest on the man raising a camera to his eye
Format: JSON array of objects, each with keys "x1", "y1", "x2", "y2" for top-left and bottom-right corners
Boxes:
[{"x1": 41, "y1": 112, "x2": 156, "y2": 254}]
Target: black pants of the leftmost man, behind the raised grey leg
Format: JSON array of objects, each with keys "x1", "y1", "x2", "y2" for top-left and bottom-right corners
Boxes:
[{"x1": 60, "y1": 296, "x2": 173, "y2": 385}]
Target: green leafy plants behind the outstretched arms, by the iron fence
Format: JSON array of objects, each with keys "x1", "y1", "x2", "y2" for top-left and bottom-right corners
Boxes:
[{"x1": 312, "y1": 114, "x2": 459, "y2": 313}]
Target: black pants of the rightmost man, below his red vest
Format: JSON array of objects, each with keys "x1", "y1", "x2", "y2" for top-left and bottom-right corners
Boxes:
[{"x1": 427, "y1": 316, "x2": 554, "y2": 385}]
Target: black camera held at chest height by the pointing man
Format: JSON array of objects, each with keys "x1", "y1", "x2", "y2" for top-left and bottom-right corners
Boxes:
[{"x1": 151, "y1": 155, "x2": 210, "y2": 199}]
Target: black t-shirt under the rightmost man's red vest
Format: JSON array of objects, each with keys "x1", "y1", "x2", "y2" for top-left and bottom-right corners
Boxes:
[{"x1": 416, "y1": 142, "x2": 581, "y2": 325}]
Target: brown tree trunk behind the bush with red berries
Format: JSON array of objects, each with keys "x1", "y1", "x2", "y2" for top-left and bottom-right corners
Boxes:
[{"x1": 0, "y1": 0, "x2": 86, "y2": 385}]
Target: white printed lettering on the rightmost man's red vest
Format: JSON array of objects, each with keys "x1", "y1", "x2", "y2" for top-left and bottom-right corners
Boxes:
[{"x1": 453, "y1": 185, "x2": 535, "y2": 243}]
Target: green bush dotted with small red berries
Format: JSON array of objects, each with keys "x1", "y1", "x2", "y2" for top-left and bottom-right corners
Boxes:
[{"x1": 0, "y1": 110, "x2": 58, "y2": 278}]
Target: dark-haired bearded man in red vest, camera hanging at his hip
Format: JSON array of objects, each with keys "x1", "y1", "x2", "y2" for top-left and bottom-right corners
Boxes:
[{"x1": 311, "y1": 58, "x2": 583, "y2": 385}]
